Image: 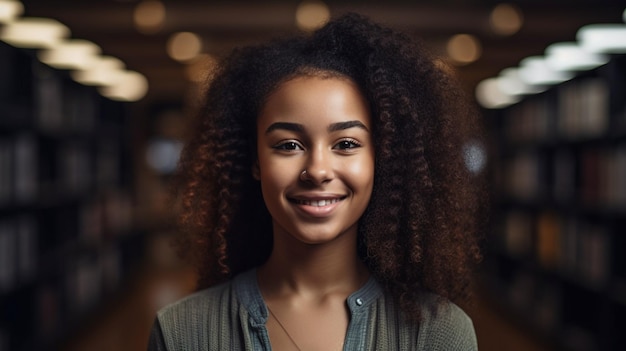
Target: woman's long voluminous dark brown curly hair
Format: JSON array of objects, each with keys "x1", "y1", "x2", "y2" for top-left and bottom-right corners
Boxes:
[{"x1": 178, "y1": 14, "x2": 480, "y2": 322}]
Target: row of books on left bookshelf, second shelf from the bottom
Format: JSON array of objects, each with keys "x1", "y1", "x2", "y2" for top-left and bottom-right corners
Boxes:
[{"x1": 0, "y1": 190, "x2": 133, "y2": 296}]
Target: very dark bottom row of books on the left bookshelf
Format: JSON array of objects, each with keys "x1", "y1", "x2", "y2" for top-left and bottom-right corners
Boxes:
[{"x1": 0, "y1": 244, "x2": 129, "y2": 350}]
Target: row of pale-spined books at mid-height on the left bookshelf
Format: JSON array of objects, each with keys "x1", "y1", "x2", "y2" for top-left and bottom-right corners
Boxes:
[{"x1": 0, "y1": 132, "x2": 123, "y2": 211}]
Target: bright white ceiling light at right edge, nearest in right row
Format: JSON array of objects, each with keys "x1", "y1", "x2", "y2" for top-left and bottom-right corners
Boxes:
[{"x1": 576, "y1": 24, "x2": 626, "y2": 54}]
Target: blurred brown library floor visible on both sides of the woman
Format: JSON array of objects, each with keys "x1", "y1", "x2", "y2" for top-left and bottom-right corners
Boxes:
[{"x1": 61, "y1": 238, "x2": 551, "y2": 351}]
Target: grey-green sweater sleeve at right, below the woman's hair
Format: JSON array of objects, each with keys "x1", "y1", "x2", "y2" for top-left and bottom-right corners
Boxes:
[{"x1": 418, "y1": 301, "x2": 478, "y2": 351}]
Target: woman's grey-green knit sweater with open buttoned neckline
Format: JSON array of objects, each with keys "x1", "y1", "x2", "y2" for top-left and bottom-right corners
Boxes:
[{"x1": 148, "y1": 270, "x2": 478, "y2": 351}]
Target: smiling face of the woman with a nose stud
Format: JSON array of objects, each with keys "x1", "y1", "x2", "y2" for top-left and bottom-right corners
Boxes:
[{"x1": 255, "y1": 76, "x2": 374, "y2": 244}]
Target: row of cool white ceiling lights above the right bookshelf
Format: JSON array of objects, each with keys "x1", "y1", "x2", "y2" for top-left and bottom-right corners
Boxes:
[{"x1": 475, "y1": 10, "x2": 626, "y2": 109}]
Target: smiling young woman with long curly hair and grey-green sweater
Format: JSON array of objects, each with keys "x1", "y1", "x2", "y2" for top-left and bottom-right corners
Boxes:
[{"x1": 149, "y1": 15, "x2": 479, "y2": 351}]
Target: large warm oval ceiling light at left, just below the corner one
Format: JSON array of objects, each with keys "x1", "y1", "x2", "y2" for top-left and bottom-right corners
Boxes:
[{"x1": 0, "y1": 17, "x2": 70, "y2": 49}]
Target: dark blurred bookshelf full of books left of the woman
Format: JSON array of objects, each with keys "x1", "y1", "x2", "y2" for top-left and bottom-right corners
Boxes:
[{"x1": 0, "y1": 42, "x2": 144, "y2": 351}]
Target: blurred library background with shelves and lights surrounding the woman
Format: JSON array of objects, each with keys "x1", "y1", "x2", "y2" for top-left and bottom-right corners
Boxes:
[{"x1": 0, "y1": 0, "x2": 626, "y2": 351}]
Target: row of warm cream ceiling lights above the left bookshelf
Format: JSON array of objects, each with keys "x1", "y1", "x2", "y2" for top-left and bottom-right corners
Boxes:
[{"x1": 0, "y1": 0, "x2": 148, "y2": 101}]
